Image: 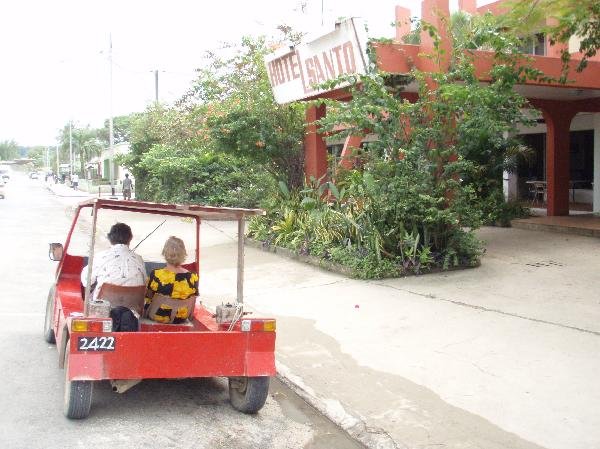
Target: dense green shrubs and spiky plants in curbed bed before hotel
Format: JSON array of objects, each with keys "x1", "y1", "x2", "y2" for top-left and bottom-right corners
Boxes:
[{"x1": 250, "y1": 13, "x2": 539, "y2": 277}]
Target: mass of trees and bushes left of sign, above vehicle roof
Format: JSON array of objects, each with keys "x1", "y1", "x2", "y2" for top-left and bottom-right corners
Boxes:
[{"x1": 120, "y1": 34, "x2": 304, "y2": 207}]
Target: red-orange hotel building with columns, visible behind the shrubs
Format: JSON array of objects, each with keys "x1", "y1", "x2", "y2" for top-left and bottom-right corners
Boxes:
[{"x1": 300, "y1": 0, "x2": 600, "y2": 216}]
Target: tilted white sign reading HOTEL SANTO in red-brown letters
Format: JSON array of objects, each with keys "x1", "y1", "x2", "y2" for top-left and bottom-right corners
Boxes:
[{"x1": 265, "y1": 18, "x2": 367, "y2": 103}]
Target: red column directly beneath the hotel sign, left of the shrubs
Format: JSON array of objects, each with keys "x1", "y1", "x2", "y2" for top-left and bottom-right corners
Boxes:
[{"x1": 304, "y1": 104, "x2": 327, "y2": 182}]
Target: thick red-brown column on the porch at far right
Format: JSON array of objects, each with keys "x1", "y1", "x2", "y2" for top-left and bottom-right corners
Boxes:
[{"x1": 542, "y1": 107, "x2": 575, "y2": 216}]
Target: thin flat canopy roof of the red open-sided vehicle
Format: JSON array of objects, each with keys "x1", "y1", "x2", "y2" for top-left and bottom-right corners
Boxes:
[{"x1": 79, "y1": 198, "x2": 265, "y2": 220}]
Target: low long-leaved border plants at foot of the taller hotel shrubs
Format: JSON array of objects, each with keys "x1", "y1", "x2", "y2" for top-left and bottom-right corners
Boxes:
[{"x1": 248, "y1": 174, "x2": 483, "y2": 278}]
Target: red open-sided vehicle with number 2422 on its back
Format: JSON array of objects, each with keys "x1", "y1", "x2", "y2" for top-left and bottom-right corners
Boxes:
[{"x1": 44, "y1": 199, "x2": 275, "y2": 418}]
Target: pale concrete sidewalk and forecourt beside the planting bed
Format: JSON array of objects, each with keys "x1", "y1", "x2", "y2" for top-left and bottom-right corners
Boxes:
[{"x1": 201, "y1": 224, "x2": 600, "y2": 449}]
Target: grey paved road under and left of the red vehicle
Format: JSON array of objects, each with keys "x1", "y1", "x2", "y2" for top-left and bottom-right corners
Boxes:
[{"x1": 0, "y1": 174, "x2": 362, "y2": 449}]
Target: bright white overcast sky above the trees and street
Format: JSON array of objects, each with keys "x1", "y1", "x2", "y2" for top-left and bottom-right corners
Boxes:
[{"x1": 0, "y1": 0, "x2": 492, "y2": 146}]
